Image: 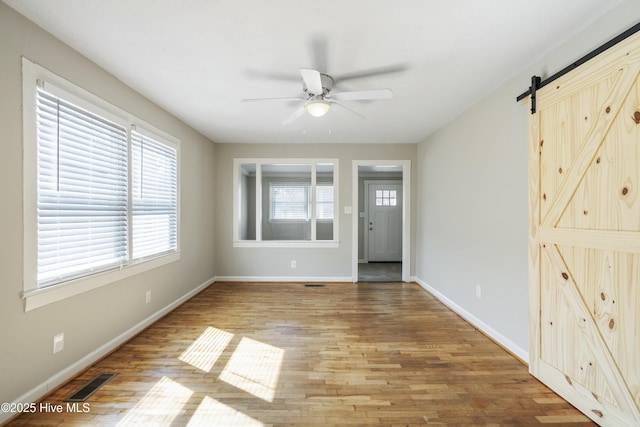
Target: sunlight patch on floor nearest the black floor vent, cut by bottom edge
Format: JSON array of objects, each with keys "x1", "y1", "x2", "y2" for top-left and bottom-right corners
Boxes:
[{"x1": 118, "y1": 377, "x2": 193, "y2": 426}]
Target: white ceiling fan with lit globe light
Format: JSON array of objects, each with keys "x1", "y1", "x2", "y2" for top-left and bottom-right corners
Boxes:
[{"x1": 242, "y1": 68, "x2": 393, "y2": 125}]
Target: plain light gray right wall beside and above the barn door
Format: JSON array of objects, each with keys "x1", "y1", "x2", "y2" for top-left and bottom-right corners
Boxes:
[{"x1": 416, "y1": 0, "x2": 640, "y2": 360}]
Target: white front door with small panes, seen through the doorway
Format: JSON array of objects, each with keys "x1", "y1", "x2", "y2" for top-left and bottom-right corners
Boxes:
[{"x1": 367, "y1": 184, "x2": 402, "y2": 262}]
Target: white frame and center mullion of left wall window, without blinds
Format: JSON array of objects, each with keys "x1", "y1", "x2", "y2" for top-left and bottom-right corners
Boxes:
[{"x1": 21, "y1": 57, "x2": 181, "y2": 311}]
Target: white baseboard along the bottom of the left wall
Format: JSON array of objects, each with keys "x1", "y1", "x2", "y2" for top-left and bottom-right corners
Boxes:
[{"x1": 0, "y1": 279, "x2": 215, "y2": 423}]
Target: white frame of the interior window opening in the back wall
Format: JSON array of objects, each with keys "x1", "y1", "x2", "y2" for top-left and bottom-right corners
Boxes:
[{"x1": 232, "y1": 158, "x2": 340, "y2": 248}]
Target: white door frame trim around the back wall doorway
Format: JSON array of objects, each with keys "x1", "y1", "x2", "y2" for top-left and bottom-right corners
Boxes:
[{"x1": 351, "y1": 160, "x2": 411, "y2": 283}]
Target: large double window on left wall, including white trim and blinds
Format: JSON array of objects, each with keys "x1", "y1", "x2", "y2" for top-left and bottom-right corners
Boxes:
[{"x1": 23, "y1": 59, "x2": 178, "y2": 308}]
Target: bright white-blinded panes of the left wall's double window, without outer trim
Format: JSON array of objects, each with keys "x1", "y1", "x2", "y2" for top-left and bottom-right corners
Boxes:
[{"x1": 36, "y1": 88, "x2": 177, "y2": 287}]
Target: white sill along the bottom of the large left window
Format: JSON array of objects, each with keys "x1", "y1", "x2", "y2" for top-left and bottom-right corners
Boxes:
[{"x1": 22, "y1": 252, "x2": 180, "y2": 312}]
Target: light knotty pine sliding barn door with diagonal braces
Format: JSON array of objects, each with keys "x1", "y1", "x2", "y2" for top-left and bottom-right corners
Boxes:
[{"x1": 529, "y1": 33, "x2": 640, "y2": 427}]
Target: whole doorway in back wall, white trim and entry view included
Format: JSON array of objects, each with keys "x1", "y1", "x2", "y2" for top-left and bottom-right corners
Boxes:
[{"x1": 352, "y1": 160, "x2": 411, "y2": 282}]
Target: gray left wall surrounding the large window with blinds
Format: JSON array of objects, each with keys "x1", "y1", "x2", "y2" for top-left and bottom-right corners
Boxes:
[{"x1": 0, "y1": 3, "x2": 215, "y2": 410}]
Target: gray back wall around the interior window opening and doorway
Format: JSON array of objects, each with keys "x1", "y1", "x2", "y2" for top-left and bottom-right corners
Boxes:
[{"x1": 215, "y1": 144, "x2": 418, "y2": 279}]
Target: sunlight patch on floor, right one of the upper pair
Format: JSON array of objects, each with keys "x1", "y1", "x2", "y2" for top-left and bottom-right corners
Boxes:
[{"x1": 220, "y1": 337, "x2": 284, "y2": 402}]
